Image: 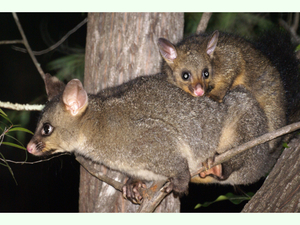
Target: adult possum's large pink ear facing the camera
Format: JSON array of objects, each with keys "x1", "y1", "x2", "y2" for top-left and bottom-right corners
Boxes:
[{"x1": 63, "y1": 79, "x2": 88, "y2": 116}]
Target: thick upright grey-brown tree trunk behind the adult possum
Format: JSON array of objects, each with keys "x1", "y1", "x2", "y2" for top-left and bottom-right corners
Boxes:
[{"x1": 79, "y1": 13, "x2": 184, "y2": 212}]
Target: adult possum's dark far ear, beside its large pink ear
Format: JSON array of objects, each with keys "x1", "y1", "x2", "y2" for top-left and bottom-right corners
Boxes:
[{"x1": 45, "y1": 73, "x2": 65, "y2": 101}]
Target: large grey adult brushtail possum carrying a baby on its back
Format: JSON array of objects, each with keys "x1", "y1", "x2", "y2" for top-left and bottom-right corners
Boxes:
[{"x1": 27, "y1": 74, "x2": 276, "y2": 194}]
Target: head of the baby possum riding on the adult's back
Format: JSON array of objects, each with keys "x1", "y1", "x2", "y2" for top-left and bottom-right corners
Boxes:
[{"x1": 158, "y1": 31, "x2": 219, "y2": 97}]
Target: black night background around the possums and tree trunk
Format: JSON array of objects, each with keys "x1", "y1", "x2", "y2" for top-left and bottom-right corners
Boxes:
[{"x1": 0, "y1": 13, "x2": 296, "y2": 212}]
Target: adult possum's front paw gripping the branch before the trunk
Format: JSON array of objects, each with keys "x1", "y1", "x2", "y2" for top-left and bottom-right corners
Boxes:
[{"x1": 122, "y1": 178, "x2": 147, "y2": 204}]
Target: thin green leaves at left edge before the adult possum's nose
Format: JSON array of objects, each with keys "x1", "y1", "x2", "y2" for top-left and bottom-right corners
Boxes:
[{"x1": 0, "y1": 109, "x2": 33, "y2": 184}]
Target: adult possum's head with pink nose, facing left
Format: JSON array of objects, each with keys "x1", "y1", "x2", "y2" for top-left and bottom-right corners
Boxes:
[{"x1": 27, "y1": 75, "x2": 88, "y2": 156}]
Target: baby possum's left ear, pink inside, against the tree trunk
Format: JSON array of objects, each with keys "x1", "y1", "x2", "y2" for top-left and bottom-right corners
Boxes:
[{"x1": 157, "y1": 38, "x2": 177, "y2": 65}]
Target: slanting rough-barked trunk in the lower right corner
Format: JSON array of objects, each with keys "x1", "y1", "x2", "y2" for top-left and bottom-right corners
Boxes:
[{"x1": 243, "y1": 134, "x2": 300, "y2": 212}]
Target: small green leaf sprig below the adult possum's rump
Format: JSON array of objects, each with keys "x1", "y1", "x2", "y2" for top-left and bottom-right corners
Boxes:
[{"x1": 195, "y1": 192, "x2": 254, "y2": 209}]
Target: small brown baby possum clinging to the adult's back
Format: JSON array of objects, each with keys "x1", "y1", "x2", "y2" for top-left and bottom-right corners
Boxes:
[{"x1": 158, "y1": 31, "x2": 293, "y2": 148}]
